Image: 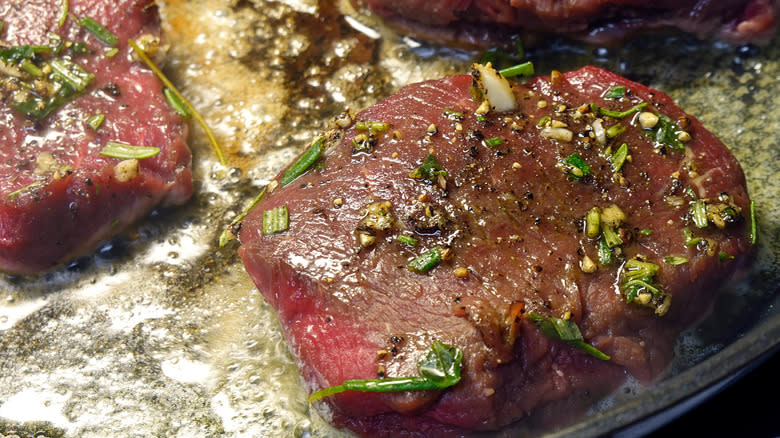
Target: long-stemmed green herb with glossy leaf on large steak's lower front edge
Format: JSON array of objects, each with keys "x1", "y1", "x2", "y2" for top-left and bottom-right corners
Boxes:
[{"x1": 309, "y1": 341, "x2": 463, "y2": 402}]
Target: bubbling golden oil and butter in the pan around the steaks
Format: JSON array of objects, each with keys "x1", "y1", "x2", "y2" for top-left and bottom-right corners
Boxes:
[{"x1": 0, "y1": 0, "x2": 780, "y2": 437}]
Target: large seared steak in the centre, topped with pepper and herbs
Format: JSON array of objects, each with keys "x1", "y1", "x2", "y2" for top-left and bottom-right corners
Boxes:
[{"x1": 238, "y1": 67, "x2": 752, "y2": 436}]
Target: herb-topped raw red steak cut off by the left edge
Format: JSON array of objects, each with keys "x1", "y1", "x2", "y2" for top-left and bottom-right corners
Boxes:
[{"x1": 0, "y1": 0, "x2": 192, "y2": 274}]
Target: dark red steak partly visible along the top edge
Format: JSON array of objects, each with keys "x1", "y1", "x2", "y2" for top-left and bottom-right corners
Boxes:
[{"x1": 356, "y1": 0, "x2": 778, "y2": 46}]
